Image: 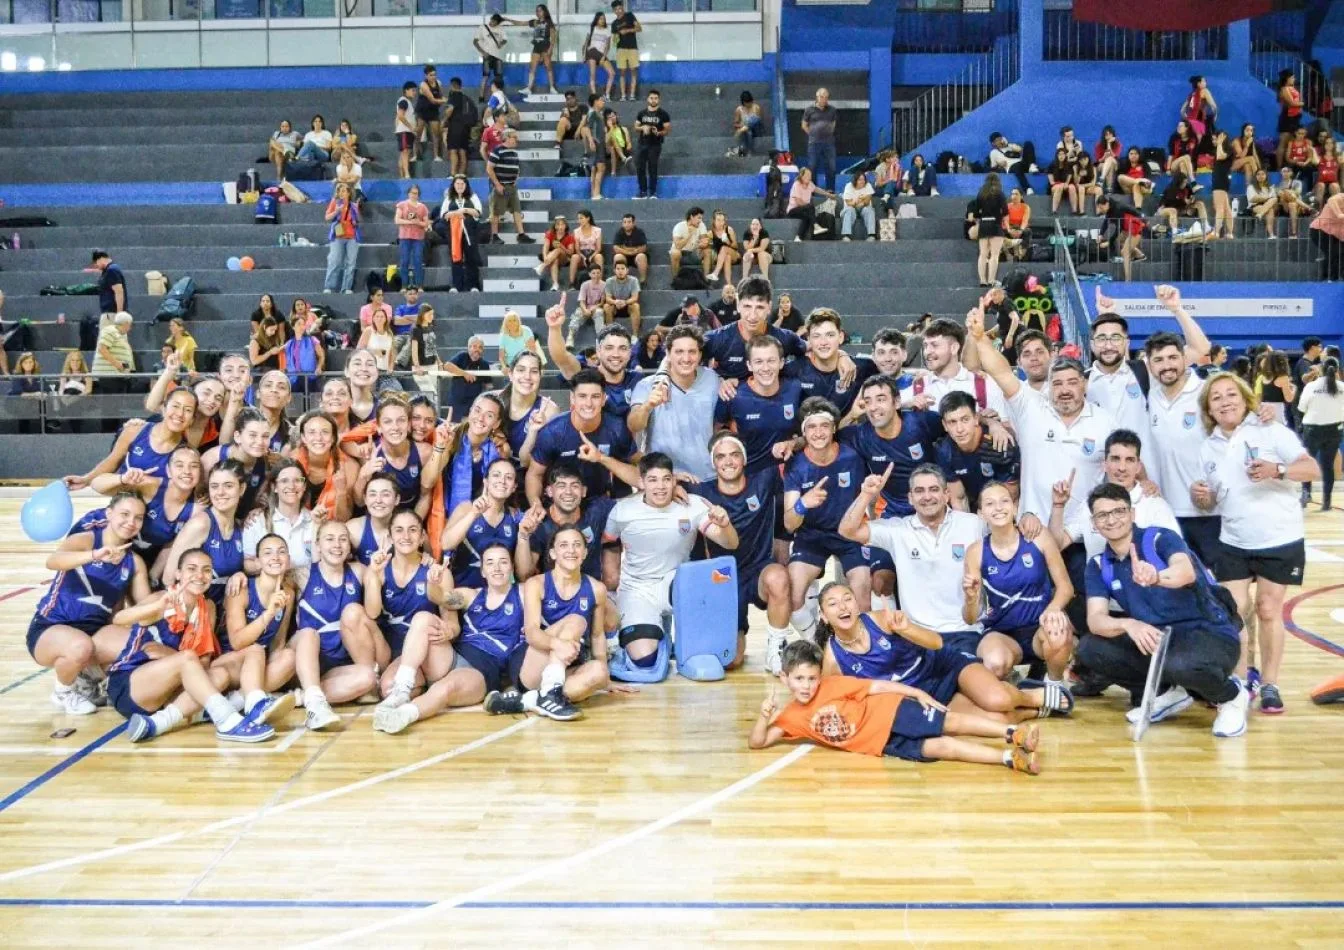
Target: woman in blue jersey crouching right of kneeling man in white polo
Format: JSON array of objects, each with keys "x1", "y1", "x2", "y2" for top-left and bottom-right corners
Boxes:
[{"x1": 962, "y1": 482, "x2": 1078, "y2": 684}]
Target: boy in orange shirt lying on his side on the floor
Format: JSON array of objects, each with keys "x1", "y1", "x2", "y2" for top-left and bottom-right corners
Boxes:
[{"x1": 747, "y1": 640, "x2": 1040, "y2": 775}]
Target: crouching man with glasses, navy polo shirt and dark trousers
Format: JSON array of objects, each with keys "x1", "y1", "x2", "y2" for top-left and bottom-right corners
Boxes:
[{"x1": 1078, "y1": 482, "x2": 1250, "y2": 738}]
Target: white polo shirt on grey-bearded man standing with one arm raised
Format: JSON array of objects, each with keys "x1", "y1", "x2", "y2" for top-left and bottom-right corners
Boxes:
[{"x1": 1008, "y1": 386, "x2": 1116, "y2": 524}]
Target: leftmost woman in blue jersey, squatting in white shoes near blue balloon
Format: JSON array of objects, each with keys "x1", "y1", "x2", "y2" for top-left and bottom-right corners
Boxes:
[{"x1": 27, "y1": 493, "x2": 149, "y2": 716}]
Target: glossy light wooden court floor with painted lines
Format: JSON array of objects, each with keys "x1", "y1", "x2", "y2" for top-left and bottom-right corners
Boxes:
[{"x1": 0, "y1": 490, "x2": 1344, "y2": 950}]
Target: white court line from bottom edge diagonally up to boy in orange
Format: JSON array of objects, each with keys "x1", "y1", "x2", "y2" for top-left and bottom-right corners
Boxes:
[{"x1": 296, "y1": 746, "x2": 816, "y2": 950}]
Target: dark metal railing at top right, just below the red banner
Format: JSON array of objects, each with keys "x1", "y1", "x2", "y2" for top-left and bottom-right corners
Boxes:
[{"x1": 1042, "y1": 4, "x2": 1227, "y2": 62}]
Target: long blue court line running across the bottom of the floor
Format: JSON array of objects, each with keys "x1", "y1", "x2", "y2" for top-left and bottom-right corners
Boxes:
[{"x1": 0, "y1": 898, "x2": 1344, "y2": 912}]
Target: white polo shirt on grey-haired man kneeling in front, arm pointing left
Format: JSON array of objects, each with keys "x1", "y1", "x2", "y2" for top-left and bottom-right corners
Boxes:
[{"x1": 868, "y1": 508, "x2": 985, "y2": 633}]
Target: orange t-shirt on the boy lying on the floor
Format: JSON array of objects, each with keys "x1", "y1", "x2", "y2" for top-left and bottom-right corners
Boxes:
[{"x1": 773, "y1": 676, "x2": 902, "y2": 755}]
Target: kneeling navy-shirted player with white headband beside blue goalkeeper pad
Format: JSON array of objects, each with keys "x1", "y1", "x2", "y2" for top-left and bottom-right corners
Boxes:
[{"x1": 688, "y1": 435, "x2": 793, "y2": 676}]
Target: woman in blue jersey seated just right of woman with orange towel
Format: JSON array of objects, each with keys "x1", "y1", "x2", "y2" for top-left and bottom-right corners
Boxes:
[{"x1": 219, "y1": 535, "x2": 297, "y2": 689}]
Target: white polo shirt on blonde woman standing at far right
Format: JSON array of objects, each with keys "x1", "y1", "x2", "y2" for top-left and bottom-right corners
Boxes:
[{"x1": 1199, "y1": 413, "x2": 1306, "y2": 551}]
